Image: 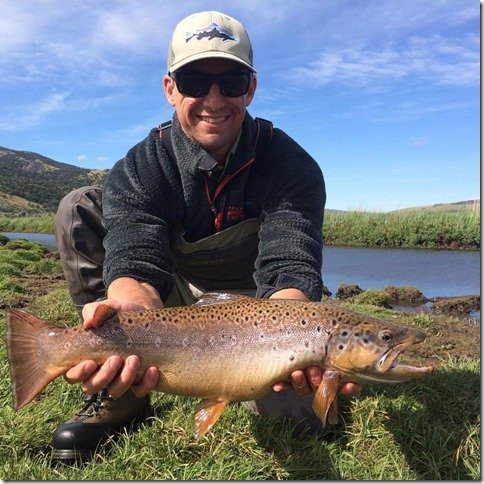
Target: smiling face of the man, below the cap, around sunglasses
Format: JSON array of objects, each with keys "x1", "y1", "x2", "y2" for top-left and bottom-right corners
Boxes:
[{"x1": 163, "y1": 59, "x2": 256, "y2": 163}]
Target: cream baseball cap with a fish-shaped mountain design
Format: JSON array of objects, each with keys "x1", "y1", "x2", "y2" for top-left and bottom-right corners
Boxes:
[{"x1": 167, "y1": 11, "x2": 255, "y2": 72}]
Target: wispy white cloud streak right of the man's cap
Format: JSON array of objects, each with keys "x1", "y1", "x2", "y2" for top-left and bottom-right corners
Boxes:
[{"x1": 289, "y1": 35, "x2": 480, "y2": 89}]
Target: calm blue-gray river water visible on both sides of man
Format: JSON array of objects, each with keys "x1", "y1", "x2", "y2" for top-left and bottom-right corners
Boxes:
[{"x1": 0, "y1": 232, "x2": 481, "y2": 298}]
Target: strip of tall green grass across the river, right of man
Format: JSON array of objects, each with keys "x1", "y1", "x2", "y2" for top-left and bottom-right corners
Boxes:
[{"x1": 324, "y1": 209, "x2": 481, "y2": 250}]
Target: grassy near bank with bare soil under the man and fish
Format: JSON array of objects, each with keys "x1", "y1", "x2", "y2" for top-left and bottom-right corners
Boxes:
[{"x1": 0, "y1": 241, "x2": 480, "y2": 480}]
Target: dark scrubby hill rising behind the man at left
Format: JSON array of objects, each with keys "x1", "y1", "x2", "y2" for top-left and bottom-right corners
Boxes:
[{"x1": 0, "y1": 146, "x2": 108, "y2": 215}]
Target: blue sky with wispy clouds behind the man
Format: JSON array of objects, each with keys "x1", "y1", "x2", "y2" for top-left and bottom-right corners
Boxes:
[{"x1": 0, "y1": 0, "x2": 480, "y2": 211}]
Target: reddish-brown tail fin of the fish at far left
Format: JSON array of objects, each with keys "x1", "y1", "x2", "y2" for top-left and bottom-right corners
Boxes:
[{"x1": 7, "y1": 309, "x2": 64, "y2": 410}]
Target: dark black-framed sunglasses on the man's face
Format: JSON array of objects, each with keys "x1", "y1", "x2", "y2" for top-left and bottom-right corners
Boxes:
[{"x1": 170, "y1": 71, "x2": 251, "y2": 97}]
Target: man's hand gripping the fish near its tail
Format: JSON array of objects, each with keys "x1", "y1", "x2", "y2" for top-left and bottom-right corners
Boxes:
[{"x1": 64, "y1": 290, "x2": 159, "y2": 397}]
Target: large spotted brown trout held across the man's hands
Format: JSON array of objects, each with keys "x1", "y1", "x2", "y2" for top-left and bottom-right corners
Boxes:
[{"x1": 7, "y1": 294, "x2": 433, "y2": 438}]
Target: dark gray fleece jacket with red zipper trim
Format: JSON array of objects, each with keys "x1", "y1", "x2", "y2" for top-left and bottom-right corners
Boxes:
[{"x1": 103, "y1": 114, "x2": 326, "y2": 301}]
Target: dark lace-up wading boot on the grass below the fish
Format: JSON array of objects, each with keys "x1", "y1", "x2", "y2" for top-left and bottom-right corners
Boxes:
[{"x1": 51, "y1": 389, "x2": 153, "y2": 463}]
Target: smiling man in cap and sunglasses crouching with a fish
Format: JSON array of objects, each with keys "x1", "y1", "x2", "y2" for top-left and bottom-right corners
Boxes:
[{"x1": 53, "y1": 12, "x2": 358, "y2": 459}]
